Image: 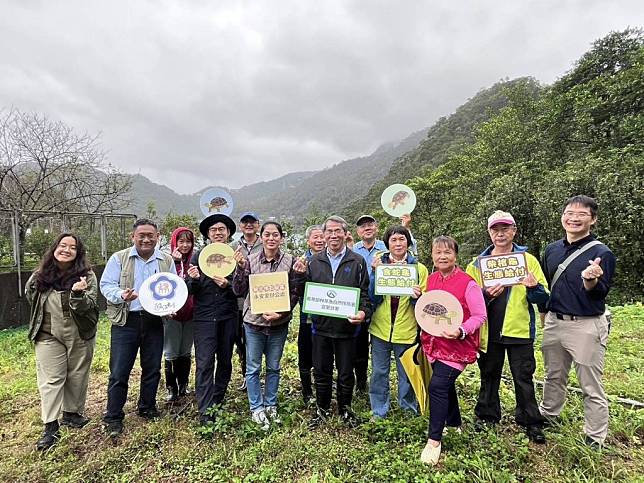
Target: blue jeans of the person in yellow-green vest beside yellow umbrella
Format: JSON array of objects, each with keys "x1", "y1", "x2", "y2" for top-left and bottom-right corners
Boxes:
[{"x1": 369, "y1": 335, "x2": 418, "y2": 418}]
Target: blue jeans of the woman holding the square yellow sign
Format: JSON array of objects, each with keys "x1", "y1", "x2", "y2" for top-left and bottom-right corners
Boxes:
[{"x1": 244, "y1": 324, "x2": 288, "y2": 411}]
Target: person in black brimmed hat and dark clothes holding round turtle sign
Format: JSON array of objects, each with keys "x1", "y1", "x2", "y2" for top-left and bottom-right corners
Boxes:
[{"x1": 186, "y1": 213, "x2": 237, "y2": 424}]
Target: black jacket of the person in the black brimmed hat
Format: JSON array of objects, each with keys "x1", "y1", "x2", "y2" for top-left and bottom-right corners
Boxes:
[{"x1": 186, "y1": 250, "x2": 237, "y2": 320}]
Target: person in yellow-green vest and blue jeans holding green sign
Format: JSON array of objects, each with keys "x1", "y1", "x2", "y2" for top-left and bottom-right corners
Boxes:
[{"x1": 369, "y1": 226, "x2": 428, "y2": 418}]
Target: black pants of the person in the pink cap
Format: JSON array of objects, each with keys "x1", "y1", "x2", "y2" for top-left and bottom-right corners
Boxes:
[{"x1": 474, "y1": 343, "x2": 543, "y2": 426}]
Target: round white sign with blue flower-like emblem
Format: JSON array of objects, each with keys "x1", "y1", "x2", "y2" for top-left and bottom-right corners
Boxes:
[{"x1": 139, "y1": 272, "x2": 188, "y2": 316}]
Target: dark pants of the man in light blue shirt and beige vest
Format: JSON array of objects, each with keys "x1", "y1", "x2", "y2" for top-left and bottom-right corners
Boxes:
[{"x1": 103, "y1": 311, "x2": 163, "y2": 423}]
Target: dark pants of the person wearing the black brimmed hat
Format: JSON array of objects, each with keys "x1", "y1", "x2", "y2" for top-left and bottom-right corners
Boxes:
[{"x1": 194, "y1": 317, "x2": 237, "y2": 414}]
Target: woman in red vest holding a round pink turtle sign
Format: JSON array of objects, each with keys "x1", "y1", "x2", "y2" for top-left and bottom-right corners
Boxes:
[{"x1": 416, "y1": 236, "x2": 485, "y2": 465}]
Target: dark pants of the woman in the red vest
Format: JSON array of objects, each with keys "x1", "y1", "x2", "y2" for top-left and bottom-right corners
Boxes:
[{"x1": 428, "y1": 361, "x2": 462, "y2": 441}]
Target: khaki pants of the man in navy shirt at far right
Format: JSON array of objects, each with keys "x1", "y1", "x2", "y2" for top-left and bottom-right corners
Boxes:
[{"x1": 540, "y1": 312, "x2": 608, "y2": 443}]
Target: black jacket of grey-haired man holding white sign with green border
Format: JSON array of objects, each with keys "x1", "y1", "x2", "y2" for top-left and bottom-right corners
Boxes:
[{"x1": 306, "y1": 248, "x2": 371, "y2": 338}]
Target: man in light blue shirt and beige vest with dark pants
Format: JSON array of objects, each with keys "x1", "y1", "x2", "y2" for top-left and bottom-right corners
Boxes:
[{"x1": 100, "y1": 218, "x2": 176, "y2": 438}]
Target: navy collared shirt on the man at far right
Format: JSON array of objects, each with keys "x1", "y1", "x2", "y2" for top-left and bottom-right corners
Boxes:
[{"x1": 540, "y1": 235, "x2": 615, "y2": 317}]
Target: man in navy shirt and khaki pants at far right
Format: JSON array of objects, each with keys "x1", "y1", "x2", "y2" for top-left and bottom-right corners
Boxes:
[{"x1": 539, "y1": 195, "x2": 615, "y2": 448}]
